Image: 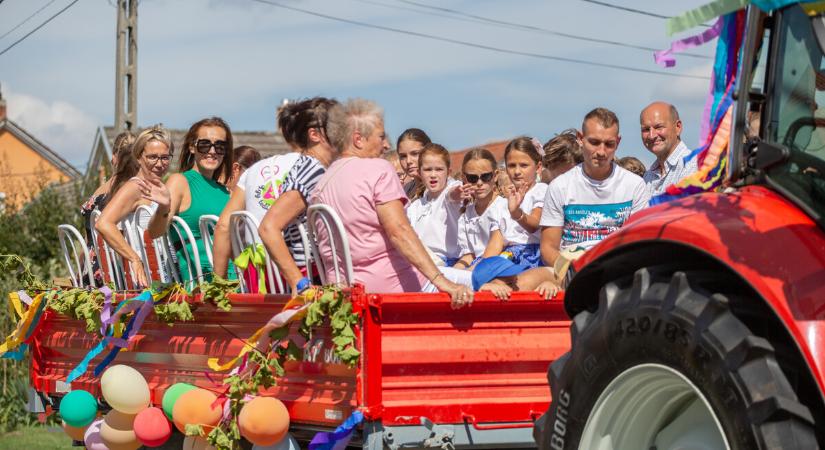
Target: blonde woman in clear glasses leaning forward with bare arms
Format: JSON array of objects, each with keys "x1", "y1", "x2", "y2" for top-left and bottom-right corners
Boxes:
[{"x1": 95, "y1": 125, "x2": 174, "y2": 287}]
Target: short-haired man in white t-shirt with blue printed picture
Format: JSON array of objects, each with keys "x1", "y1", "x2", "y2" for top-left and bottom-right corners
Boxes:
[{"x1": 540, "y1": 108, "x2": 650, "y2": 267}]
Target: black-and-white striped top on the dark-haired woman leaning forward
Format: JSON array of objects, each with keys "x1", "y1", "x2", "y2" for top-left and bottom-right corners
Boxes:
[{"x1": 281, "y1": 155, "x2": 326, "y2": 266}]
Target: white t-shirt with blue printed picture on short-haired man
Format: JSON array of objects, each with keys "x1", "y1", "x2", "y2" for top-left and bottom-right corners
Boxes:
[{"x1": 540, "y1": 164, "x2": 650, "y2": 249}]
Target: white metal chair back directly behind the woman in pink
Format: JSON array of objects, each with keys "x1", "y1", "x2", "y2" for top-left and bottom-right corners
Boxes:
[{"x1": 307, "y1": 203, "x2": 355, "y2": 285}]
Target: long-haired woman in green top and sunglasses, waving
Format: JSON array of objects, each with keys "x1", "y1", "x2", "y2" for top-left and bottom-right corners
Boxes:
[{"x1": 147, "y1": 117, "x2": 234, "y2": 280}]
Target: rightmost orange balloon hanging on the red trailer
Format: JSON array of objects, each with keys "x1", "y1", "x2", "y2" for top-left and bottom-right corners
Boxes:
[{"x1": 238, "y1": 397, "x2": 289, "y2": 446}]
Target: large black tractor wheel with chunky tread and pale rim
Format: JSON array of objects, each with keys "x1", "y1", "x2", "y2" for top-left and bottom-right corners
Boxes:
[{"x1": 534, "y1": 269, "x2": 818, "y2": 450}]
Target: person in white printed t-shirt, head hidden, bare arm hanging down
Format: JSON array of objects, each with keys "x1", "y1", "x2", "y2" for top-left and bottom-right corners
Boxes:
[{"x1": 212, "y1": 152, "x2": 301, "y2": 277}]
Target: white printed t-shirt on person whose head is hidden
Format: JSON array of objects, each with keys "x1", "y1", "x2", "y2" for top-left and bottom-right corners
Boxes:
[{"x1": 238, "y1": 153, "x2": 301, "y2": 223}]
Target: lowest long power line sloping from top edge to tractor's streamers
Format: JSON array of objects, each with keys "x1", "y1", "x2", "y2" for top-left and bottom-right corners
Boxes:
[{"x1": 249, "y1": 0, "x2": 710, "y2": 80}]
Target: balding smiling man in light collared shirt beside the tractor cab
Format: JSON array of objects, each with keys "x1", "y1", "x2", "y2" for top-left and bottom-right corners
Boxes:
[{"x1": 639, "y1": 102, "x2": 698, "y2": 196}]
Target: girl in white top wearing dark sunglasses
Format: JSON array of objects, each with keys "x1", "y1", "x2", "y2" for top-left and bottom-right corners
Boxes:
[{"x1": 454, "y1": 148, "x2": 509, "y2": 269}]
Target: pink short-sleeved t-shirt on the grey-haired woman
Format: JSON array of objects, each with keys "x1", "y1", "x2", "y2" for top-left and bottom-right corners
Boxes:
[{"x1": 310, "y1": 157, "x2": 426, "y2": 293}]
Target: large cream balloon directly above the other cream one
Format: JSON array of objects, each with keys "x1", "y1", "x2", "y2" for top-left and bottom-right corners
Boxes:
[{"x1": 100, "y1": 364, "x2": 149, "y2": 414}]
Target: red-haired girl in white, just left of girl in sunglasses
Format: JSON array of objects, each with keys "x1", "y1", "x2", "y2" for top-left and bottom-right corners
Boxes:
[{"x1": 407, "y1": 144, "x2": 470, "y2": 267}]
